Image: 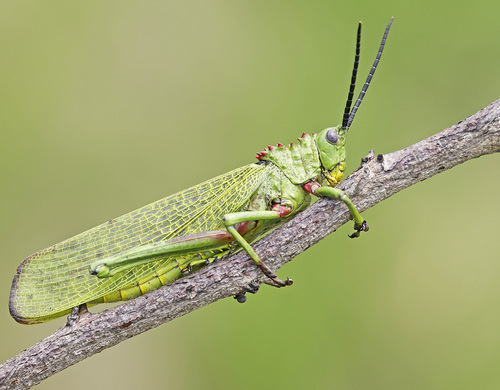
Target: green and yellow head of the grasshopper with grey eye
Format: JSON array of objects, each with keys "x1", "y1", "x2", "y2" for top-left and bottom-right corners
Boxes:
[{"x1": 316, "y1": 126, "x2": 347, "y2": 187}]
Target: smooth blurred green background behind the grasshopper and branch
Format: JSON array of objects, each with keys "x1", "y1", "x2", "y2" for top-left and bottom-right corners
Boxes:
[{"x1": 0, "y1": 0, "x2": 500, "y2": 390}]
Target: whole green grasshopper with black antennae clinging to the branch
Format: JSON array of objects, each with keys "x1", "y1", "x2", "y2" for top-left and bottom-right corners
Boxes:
[{"x1": 9, "y1": 18, "x2": 392, "y2": 324}]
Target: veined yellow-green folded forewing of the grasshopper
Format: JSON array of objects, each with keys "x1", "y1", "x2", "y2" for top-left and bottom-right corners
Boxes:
[{"x1": 10, "y1": 164, "x2": 266, "y2": 323}]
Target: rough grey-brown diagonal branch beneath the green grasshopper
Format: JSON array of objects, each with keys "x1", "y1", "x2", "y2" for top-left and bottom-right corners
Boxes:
[{"x1": 0, "y1": 100, "x2": 500, "y2": 389}]
